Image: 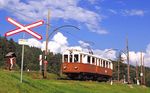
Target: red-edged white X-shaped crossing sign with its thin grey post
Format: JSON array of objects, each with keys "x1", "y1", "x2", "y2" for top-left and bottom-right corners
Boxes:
[{"x1": 5, "y1": 17, "x2": 44, "y2": 83}]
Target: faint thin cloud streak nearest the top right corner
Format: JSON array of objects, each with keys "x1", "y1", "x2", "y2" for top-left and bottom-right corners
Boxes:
[{"x1": 122, "y1": 9, "x2": 145, "y2": 16}]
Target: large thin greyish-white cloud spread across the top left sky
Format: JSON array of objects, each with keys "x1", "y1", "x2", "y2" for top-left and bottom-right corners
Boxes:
[{"x1": 0, "y1": 0, "x2": 107, "y2": 34}]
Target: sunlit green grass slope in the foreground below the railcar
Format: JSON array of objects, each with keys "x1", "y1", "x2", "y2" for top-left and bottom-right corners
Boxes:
[{"x1": 0, "y1": 70, "x2": 150, "y2": 93}]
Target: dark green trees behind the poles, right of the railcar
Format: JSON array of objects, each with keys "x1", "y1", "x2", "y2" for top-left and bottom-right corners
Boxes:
[{"x1": 112, "y1": 61, "x2": 150, "y2": 87}]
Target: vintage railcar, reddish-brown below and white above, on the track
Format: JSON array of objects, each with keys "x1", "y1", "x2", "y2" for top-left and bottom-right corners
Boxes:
[{"x1": 62, "y1": 49, "x2": 113, "y2": 81}]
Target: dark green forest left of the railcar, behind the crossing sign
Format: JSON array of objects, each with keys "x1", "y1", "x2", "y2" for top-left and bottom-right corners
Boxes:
[{"x1": 0, "y1": 37, "x2": 61, "y2": 74}]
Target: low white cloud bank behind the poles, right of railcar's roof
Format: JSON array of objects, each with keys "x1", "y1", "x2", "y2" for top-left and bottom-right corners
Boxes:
[{"x1": 93, "y1": 44, "x2": 150, "y2": 67}]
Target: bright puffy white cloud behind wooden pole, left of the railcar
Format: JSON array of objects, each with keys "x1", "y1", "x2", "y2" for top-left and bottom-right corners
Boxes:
[{"x1": 25, "y1": 32, "x2": 68, "y2": 53}]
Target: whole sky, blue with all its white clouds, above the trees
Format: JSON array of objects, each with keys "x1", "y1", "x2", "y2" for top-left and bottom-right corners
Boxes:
[{"x1": 0, "y1": 0, "x2": 150, "y2": 66}]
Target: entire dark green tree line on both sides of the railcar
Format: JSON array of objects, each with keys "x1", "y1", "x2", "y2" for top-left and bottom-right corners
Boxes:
[{"x1": 0, "y1": 37, "x2": 150, "y2": 86}]
